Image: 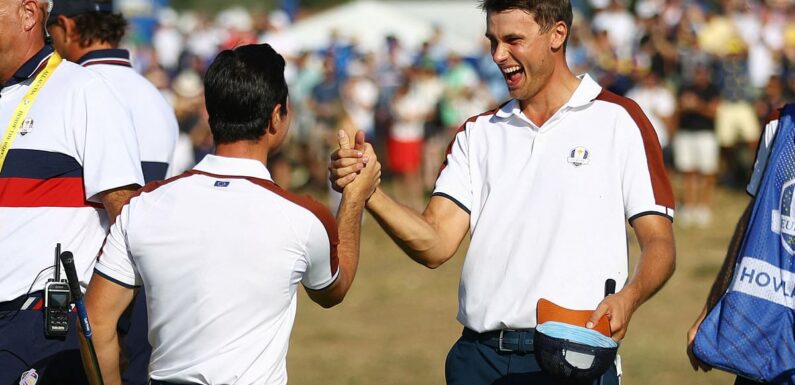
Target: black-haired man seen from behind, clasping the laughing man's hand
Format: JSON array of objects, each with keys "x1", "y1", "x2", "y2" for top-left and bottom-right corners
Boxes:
[{"x1": 86, "y1": 45, "x2": 380, "y2": 385}]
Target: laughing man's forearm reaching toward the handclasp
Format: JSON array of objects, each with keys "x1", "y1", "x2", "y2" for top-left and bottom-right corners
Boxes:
[{"x1": 367, "y1": 189, "x2": 455, "y2": 268}]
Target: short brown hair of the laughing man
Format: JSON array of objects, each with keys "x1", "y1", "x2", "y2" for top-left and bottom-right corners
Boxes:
[{"x1": 480, "y1": 0, "x2": 574, "y2": 41}]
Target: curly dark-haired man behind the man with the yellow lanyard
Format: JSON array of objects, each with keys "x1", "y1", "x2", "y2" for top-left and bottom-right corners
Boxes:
[{"x1": 47, "y1": 0, "x2": 178, "y2": 385}]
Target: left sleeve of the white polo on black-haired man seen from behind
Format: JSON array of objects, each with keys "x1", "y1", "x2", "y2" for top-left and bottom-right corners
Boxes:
[{"x1": 94, "y1": 205, "x2": 142, "y2": 288}]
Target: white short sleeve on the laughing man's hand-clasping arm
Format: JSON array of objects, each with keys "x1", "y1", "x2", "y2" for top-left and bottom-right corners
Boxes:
[{"x1": 433, "y1": 127, "x2": 472, "y2": 214}]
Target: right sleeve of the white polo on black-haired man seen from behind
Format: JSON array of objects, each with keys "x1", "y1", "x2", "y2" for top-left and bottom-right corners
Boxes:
[{"x1": 301, "y1": 213, "x2": 339, "y2": 290}]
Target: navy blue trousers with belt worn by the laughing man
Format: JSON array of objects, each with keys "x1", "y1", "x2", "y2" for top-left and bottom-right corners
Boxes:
[{"x1": 444, "y1": 328, "x2": 618, "y2": 385}]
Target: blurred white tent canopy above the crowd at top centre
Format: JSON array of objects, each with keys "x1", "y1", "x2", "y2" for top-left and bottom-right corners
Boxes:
[{"x1": 266, "y1": 1, "x2": 485, "y2": 55}]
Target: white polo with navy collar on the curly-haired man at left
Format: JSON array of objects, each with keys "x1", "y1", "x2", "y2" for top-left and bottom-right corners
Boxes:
[{"x1": 77, "y1": 49, "x2": 179, "y2": 183}]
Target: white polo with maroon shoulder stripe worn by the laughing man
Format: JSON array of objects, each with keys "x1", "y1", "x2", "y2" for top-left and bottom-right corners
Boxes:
[{"x1": 434, "y1": 75, "x2": 674, "y2": 332}]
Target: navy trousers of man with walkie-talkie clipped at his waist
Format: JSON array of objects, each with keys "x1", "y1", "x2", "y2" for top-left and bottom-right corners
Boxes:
[{"x1": 0, "y1": 304, "x2": 88, "y2": 385}]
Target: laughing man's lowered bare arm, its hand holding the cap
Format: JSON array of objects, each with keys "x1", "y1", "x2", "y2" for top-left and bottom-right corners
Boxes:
[{"x1": 586, "y1": 215, "x2": 676, "y2": 341}]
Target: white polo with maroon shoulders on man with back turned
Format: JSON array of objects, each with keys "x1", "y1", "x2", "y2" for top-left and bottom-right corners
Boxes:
[{"x1": 96, "y1": 155, "x2": 338, "y2": 384}]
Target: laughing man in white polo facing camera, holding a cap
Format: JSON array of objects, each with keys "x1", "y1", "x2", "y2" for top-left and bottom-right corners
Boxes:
[{"x1": 332, "y1": 0, "x2": 675, "y2": 385}]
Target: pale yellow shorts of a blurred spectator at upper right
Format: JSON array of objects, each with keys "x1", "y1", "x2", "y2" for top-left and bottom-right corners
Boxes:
[{"x1": 715, "y1": 101, "x2": 761, "y2": 147}]
